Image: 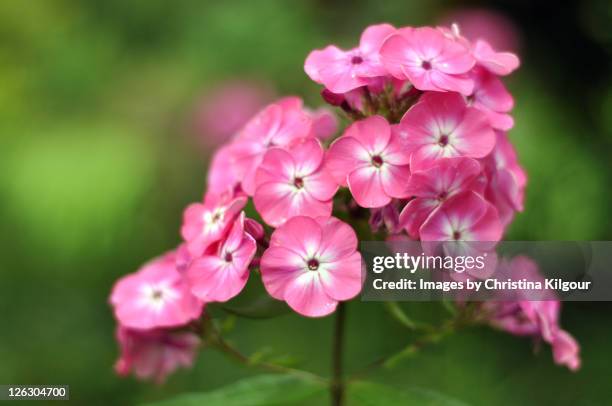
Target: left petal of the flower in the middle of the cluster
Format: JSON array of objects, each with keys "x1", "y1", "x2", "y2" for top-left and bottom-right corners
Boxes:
[{"x1": 325, "y1": 136, "x2": 371, "y2": 186}]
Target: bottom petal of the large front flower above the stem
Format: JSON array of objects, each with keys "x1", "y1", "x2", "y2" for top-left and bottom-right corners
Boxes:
[{"x1": 285, "y1": 271, "x2": 338, "y2": 317}]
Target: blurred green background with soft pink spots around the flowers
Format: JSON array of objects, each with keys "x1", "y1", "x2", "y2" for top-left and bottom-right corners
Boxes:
[{"x1": 0, "y1": 0, "x2": 612, "y2": 405}]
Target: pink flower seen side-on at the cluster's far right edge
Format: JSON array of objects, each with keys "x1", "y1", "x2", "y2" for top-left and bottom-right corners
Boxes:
[{"x1": 483, "y1": 132, "x2": 527, "y2": 225}]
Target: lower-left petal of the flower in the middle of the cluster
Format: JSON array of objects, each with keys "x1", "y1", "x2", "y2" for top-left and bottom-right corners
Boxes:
[{"x1": 348, "y1": 166, "x2": 391, "y2": 208}]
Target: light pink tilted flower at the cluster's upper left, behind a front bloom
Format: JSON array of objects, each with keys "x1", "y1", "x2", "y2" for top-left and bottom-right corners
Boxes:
[{"x1": 228, "y1": 98, "x2": 312, "y2": 196}]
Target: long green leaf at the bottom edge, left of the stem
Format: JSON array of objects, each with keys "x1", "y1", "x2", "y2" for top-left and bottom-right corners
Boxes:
[{"x1": 148, "y1": 375, "x2": 327, "y2": 406}]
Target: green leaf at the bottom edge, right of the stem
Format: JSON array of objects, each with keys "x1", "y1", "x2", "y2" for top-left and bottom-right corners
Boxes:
[{"x1": 348, "y1": 382, "x2": 467, "y2": 406}]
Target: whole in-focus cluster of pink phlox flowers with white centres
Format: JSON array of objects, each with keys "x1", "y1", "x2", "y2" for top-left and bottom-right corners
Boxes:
[{"x1": 110, "y1": 24, "x2": 580, "y2": 380}]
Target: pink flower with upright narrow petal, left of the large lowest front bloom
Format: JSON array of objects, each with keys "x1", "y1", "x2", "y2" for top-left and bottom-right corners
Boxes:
[{"x1": 186, "y1": 212, "x2": 257, "y2": 302}]
